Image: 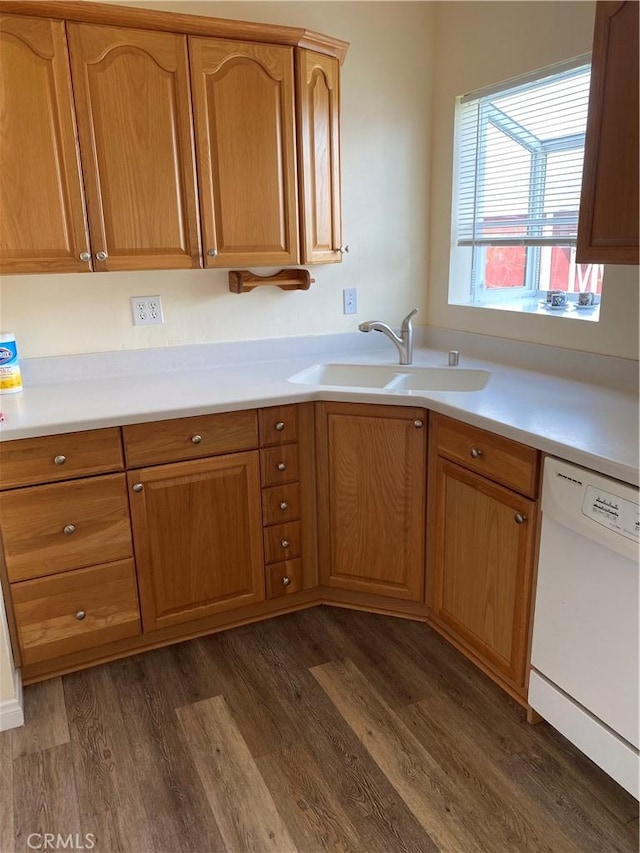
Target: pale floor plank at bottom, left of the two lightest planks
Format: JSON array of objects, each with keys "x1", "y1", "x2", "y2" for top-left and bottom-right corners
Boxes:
[{"x1": 176, "y1": 696, "x2": 297, "y2": 853}]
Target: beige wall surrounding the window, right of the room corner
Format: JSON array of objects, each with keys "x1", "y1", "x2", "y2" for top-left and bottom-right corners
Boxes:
[{"x1": 428, "y1": 0, "x2": 640, "y2": 359}]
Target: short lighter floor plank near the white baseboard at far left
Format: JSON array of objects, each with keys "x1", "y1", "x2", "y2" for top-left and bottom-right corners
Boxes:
[{"x1": 12, "y1": 678, "x2": 69, "y2": 759}]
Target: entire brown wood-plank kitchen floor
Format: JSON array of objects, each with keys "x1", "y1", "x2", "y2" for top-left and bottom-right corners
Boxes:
[{"x1": 0, "y1": 607, "x2": 638, "y2": 853}]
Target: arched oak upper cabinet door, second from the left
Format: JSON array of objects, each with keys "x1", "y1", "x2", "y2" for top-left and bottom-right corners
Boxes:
[{"x1": 68, "y1": 24, "x2": 201, "y2": 270}]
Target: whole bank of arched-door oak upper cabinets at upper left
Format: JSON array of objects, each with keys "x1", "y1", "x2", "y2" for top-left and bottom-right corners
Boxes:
[{"x1": 0, "y1": 0, "x2": 348, "y2": 273}]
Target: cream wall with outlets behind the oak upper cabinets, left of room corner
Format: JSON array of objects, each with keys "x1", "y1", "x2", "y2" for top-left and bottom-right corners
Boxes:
[{"x1": 0, "y1": 0, "x2": 434, "y2": 358}]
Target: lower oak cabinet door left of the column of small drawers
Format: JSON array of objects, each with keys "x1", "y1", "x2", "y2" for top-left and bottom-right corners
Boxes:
[{"x1": 128, "y1": 451, "x2": 265, "y2": 631}]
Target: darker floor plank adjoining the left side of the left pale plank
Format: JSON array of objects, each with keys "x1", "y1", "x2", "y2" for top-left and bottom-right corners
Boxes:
[{"x1": 109, "y1": 653, "x2": 229, "y2": 853}]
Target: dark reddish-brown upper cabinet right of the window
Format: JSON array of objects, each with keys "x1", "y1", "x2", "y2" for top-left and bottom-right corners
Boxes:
[{"x1": 576, "y1": 0, "x2": 640, "y2": 264}]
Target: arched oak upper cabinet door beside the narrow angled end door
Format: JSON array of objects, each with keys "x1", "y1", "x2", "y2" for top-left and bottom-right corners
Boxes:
[{"x1": 189, "y1": 38, "x2": 299, "y2": 267}]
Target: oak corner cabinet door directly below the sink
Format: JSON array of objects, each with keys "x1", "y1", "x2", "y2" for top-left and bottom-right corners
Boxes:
[{"x1": 317, "y1": 403, "x2": 427, "y2": 601}]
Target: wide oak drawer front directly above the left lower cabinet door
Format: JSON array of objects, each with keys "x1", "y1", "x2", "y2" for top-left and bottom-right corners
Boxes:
[{"x1": 122, "y1": 409, "x2": 258, "y2": 468}]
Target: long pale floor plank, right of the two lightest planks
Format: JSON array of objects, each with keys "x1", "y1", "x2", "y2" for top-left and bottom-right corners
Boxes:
[{"x1": 311, "y1": 660, "x2": 500, "y2": 853}]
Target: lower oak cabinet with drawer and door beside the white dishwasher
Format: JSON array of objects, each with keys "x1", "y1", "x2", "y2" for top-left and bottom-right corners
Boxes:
[{"x1": 427, "y1": 416, "x2": 537, "y2": 694}]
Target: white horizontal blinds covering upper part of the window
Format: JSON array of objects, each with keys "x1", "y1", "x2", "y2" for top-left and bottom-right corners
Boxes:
[{"x1": 455, "y1": 57, "x2": 590, "y2": 246}]
